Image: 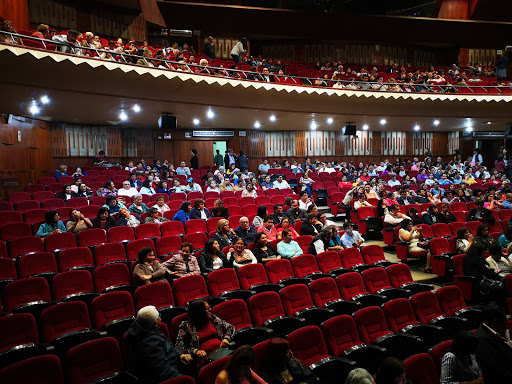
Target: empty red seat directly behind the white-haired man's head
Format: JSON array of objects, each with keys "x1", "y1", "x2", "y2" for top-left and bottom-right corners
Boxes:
[{"x1": 134, "y1": 281, "x2": 185, "y2": 324}]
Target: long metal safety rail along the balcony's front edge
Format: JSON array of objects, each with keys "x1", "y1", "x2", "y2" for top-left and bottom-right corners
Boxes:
[{"x1": 0, "y1": 31, "x2": 512, "y2": 96}]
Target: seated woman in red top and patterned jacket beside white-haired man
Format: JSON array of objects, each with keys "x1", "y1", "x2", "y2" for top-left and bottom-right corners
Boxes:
[{"x1": 176, "y1": 299, "x2": 235, "y2": 364}]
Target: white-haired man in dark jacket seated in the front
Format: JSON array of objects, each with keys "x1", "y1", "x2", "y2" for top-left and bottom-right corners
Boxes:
[{"x1": 126, "y1": 305, "x2": 192, "y2": 384}]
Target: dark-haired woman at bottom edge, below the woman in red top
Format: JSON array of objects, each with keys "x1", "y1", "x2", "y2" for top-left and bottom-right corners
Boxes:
[{"x1": 215, "y1": 345, "x2": 266, "y2": 384}]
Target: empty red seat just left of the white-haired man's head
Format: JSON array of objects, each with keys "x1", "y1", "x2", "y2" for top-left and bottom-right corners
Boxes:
[{"x1": 91, "y1": 291, "x2": 135, "y2": 340}]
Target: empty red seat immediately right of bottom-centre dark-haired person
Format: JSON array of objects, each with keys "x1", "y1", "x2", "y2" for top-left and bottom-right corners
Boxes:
[{"x1": 288, "y1": 325, "x2": 356, "y2": 383}]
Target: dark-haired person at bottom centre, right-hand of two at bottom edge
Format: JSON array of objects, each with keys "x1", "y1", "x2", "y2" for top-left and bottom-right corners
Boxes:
[{"x1": 261, "y1": 338, "x2": 319, "y2": 384}]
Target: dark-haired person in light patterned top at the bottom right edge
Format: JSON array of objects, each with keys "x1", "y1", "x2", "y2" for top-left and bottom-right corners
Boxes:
[{"x1": 440, "y1": 331, "x2": 484, "y2": 384}]
